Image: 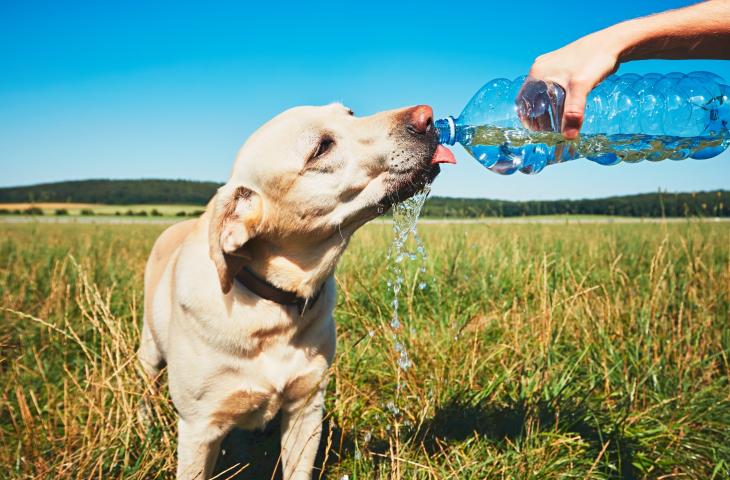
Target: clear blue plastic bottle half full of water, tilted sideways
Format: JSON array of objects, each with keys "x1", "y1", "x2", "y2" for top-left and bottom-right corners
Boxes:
[{"x1": 435, "y1": 72, "x2": 730, "y2": 175}]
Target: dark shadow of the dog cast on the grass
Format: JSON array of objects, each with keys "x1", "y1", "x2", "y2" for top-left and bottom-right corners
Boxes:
[{"x1": 215, "y1": 392, "x2": 639, "y2": 480}]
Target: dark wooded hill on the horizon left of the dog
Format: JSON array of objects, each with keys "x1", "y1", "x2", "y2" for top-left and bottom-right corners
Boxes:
[{"x1": 0, "y1": 179, "x2": 221, "y2": 205}]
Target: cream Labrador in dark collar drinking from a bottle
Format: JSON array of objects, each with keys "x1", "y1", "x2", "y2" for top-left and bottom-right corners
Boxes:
[{"x1": 138, "y1": 104, "x2": 453, "y2": 480}]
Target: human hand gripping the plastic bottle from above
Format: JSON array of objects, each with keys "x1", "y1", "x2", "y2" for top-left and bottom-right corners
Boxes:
[{"x1": 529, "y1": 30, "x2": 621, "y2": 140}]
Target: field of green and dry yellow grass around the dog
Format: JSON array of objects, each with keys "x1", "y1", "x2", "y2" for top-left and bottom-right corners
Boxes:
[{"x1": 0, "y1": 222, "x2": 730, "y2": 479}]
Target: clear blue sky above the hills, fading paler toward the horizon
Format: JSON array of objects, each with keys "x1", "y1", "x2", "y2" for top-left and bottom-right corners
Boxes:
[{"x1": 0, "y1": 0, "x2": 730, "y2": 200}]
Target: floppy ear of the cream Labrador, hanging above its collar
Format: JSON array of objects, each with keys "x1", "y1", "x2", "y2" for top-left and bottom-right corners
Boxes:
[{"x1": 208, "y1": 185, "x2": 262, "y2": 293}]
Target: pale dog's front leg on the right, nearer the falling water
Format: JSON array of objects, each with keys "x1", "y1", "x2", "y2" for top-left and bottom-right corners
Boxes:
[{"x1": 281, "y1": 388, "x2": 324, "y2": 480}]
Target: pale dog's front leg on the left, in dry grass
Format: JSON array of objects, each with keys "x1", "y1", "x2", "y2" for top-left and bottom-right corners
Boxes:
[{"x1": 177, "y1": 418, "x2": 225, "y2": 480}]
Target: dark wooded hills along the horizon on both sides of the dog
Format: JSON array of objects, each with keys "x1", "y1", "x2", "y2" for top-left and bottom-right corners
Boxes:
[{"x1": 0, "y1": 180, "x2": 730, "y2": 218}]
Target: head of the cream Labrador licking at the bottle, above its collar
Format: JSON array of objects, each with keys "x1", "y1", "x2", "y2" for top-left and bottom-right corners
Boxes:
[{"x1": 210, "y1": 104, "x2": 452, "y2": 294}]
